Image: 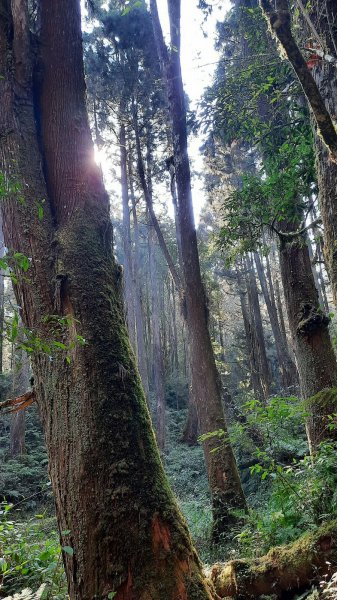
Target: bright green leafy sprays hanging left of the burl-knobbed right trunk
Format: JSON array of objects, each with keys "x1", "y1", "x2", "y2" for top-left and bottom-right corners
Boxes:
[{"x1": 218, "y1": 126, "x2": 315, "y2": 262}]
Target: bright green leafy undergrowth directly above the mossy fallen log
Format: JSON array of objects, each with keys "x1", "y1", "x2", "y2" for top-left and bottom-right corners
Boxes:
[{"x1": 232, "y1": 397, "x2": 337, "y2": 555}]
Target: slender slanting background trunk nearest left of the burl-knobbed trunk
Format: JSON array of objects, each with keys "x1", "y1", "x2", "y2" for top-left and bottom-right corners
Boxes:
[{"x1": 254, "y1": 252, "x2": 298, "y2": 391}]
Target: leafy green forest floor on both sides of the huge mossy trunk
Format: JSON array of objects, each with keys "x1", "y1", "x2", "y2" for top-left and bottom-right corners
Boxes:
[{"x1": 0, "y1": 400, "x2": 337, "y2": 600}]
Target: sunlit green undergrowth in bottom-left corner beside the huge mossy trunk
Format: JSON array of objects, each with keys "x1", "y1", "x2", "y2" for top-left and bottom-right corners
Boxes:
[{"x1": 0, "y1": 503, "x2": 65, "y2": 600}]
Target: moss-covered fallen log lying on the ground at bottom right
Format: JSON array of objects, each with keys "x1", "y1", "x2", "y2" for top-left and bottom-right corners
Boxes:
[{"x1": 210, "y1": 521, "x2": 337, "y2": 600}]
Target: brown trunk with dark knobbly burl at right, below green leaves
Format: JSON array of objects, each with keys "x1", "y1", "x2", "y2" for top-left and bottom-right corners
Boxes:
[{"x1": 280, "y1": 224, "x2": 337, "y2": 451}]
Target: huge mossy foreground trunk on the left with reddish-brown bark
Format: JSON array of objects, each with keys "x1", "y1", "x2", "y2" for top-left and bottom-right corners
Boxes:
[{"x1": 0, "y1": 0, "x2": 214, "y2": 600}]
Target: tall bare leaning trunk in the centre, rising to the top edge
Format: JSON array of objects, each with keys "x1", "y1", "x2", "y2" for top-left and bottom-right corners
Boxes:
[{"x1": 151, "y1": 0, "x2": 246, "y2": 539}]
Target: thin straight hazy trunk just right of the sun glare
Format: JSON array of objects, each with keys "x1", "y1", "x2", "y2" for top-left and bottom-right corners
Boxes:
[{"x1": 119, "y1": 121, "x2": 137, "y2": 351}]
